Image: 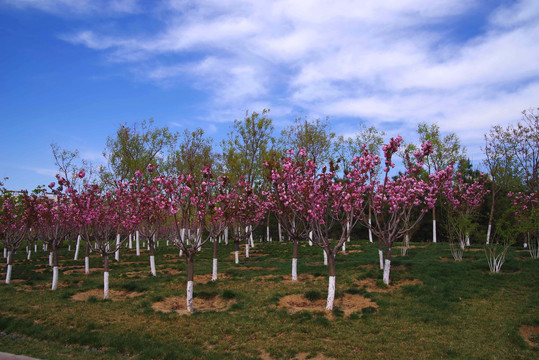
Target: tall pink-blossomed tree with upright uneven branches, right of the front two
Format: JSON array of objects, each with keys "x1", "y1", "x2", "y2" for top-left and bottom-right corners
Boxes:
[{"x1": 369, "y1": 136, "x2": 453, "y2": 284}]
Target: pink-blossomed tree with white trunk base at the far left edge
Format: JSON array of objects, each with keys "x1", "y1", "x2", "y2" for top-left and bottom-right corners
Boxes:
[{"x1": 0, "y1": 183, "x2": 30, "y2": 284}]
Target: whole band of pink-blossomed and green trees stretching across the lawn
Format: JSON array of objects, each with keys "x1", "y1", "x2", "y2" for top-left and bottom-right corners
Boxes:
[{"x1": 0, "y1": 107, "x2": 538, "y2": 310}]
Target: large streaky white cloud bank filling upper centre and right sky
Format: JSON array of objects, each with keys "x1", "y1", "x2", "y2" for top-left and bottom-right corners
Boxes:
[{"x1": 23, "y1": 0, "x2": 539, "y2": 160}]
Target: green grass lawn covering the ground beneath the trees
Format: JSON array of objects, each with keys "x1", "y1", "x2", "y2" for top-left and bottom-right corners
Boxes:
[{"x1": 0, "y1": 240, "x2": 539, "y2": 359}]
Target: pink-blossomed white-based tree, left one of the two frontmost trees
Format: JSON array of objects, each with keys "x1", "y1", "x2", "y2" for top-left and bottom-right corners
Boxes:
[{"x1": 158, "y1": 166, "x2": 230, "y2": 312}]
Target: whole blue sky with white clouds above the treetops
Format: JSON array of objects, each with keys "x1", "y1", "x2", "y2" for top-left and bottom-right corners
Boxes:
[{"x1": 0, "y1": 0, "x2": 539, "y2": 189}]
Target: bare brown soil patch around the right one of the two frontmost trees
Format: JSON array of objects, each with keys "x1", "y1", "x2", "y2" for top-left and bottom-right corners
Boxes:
[{"x1": 279, "y1": 294, "x2": 378, "y2": 319}]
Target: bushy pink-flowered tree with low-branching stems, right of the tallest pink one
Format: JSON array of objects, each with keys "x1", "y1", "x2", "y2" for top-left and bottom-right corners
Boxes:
[{"x1": 442, "y1": 172, "x2": 488, "y2": 261}]
